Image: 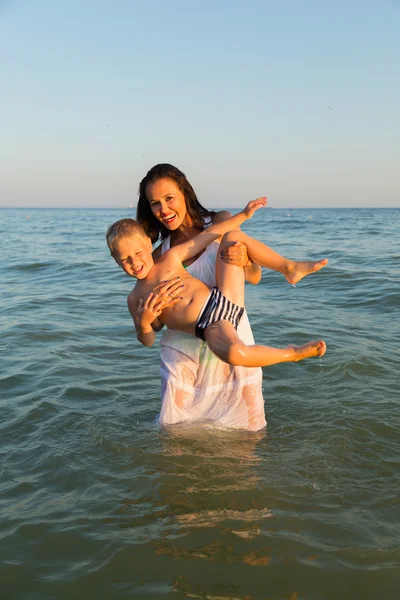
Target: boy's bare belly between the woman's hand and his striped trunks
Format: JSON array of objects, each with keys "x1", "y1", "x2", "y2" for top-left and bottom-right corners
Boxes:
[{"x1": 160, "y1": 277, "x2": 210, "y2": 334}]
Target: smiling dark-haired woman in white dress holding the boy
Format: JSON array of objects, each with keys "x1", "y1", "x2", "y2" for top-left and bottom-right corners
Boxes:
[{"x1": 137, "y1": 164, "x2": 324, "y2": 431}]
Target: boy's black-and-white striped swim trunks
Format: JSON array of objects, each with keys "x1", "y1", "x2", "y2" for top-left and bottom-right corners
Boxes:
[{"x1": 195, "y1": 287, "x2": 244, "y2": 340}]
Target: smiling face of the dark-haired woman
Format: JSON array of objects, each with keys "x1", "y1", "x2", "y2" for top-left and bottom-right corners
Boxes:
[{"x1": 146, "y1": 178, "x2": 187, "y2": 231}]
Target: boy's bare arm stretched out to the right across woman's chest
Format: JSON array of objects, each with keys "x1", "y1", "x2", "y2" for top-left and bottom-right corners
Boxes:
[{"x1": 168, "y1": 197, "x2": 267, "y2": 262}]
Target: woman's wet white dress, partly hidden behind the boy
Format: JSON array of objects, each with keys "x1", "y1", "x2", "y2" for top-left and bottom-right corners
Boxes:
[{"x1": 159, "y1": 238, "x2": 266, "y2": 431}]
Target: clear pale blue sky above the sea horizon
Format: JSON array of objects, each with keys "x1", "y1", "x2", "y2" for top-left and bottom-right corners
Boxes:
[{"x1": 0, "y1": 0, "x2": 400, "y2": 208}]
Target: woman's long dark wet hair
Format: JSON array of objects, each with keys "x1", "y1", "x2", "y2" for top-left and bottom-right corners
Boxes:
[{"x1": 136, "y1": 163, "x2": 215, "y2": 244}]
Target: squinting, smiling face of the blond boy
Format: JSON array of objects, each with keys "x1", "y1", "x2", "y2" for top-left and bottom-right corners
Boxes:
[{"x1": 115, "y1": 236, "x2": 154, "y2": 279}]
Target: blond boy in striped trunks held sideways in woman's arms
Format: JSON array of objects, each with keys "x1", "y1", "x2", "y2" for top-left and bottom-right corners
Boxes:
[{"x1": 106, "y1": 198, "x2": 327, "y2": 367}]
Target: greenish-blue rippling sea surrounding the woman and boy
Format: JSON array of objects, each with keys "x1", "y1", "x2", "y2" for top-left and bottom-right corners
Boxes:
[{"x1": 0, "y1": 208, "x2": 400, "y2": 600}]
